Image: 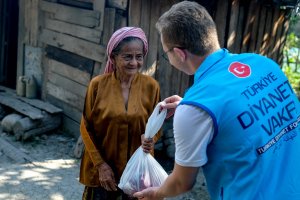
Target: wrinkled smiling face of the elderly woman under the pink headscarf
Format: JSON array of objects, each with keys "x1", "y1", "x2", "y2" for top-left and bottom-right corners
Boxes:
[{"x1": 112, "y1": 40, "x2": 144, "y2": 75}]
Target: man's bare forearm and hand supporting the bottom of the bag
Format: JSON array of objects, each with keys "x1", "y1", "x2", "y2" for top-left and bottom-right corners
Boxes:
[{"x1": 133, "y1": 163, "x2": 199, "y2": 200}]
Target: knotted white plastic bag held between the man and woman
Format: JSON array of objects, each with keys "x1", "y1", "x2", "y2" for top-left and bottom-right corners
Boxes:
[{"x1": 118, "y1": 102, "x2": 168, "y2": 195}]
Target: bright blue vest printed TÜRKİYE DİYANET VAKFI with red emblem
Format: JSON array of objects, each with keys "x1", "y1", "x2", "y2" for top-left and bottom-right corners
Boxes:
[{"x1": 180, "y1": 49, "x2": 300, "y2": 200}]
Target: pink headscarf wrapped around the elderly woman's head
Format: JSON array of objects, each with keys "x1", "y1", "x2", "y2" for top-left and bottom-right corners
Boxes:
[{"x1": 104, "y1": 27, "x2": 148, "y2": 74}]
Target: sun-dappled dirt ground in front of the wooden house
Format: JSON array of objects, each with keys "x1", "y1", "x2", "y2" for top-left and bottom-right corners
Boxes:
[{"x1": 0, "y1": 131, "x2": 209, "y2": 200}]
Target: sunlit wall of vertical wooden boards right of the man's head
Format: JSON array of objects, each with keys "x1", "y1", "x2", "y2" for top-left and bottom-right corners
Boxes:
[{"x1": 212, "y1": 0, "x2": 290, "y2": 64}]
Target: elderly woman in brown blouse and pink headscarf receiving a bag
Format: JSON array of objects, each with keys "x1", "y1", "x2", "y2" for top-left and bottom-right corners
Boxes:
[{"x1": 79, "y1": 27, "x2": 160, "y2": 200}]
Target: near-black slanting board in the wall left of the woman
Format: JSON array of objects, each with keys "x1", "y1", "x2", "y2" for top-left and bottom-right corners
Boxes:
[{"x1": 45, "y1": 45, "x2": 94, "y2": 74}]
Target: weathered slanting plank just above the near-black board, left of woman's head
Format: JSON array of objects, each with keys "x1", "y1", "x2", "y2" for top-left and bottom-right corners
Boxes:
[{"x1": 40, "y1": 29, "x2": 105, "y2": 62}]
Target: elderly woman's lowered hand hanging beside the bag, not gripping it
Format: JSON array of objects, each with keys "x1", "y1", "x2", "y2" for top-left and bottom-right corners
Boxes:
[{"x1": 98, "y1": 163, "x2": 117, "y2": 191}]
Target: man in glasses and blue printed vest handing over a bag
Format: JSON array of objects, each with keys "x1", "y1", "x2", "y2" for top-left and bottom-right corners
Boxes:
[{"x1": 134, "y1": 1, "x2": 300, "y2": 200}]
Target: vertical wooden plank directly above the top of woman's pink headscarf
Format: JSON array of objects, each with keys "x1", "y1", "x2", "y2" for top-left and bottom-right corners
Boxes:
[{"x1": 128, "y1": 0, "x2": 142, "y2": 27}]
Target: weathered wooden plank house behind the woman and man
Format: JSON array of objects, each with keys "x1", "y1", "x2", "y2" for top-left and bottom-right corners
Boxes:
[{"x1": 0, "y1": 0, "x2": 298, "y2": 137}]
